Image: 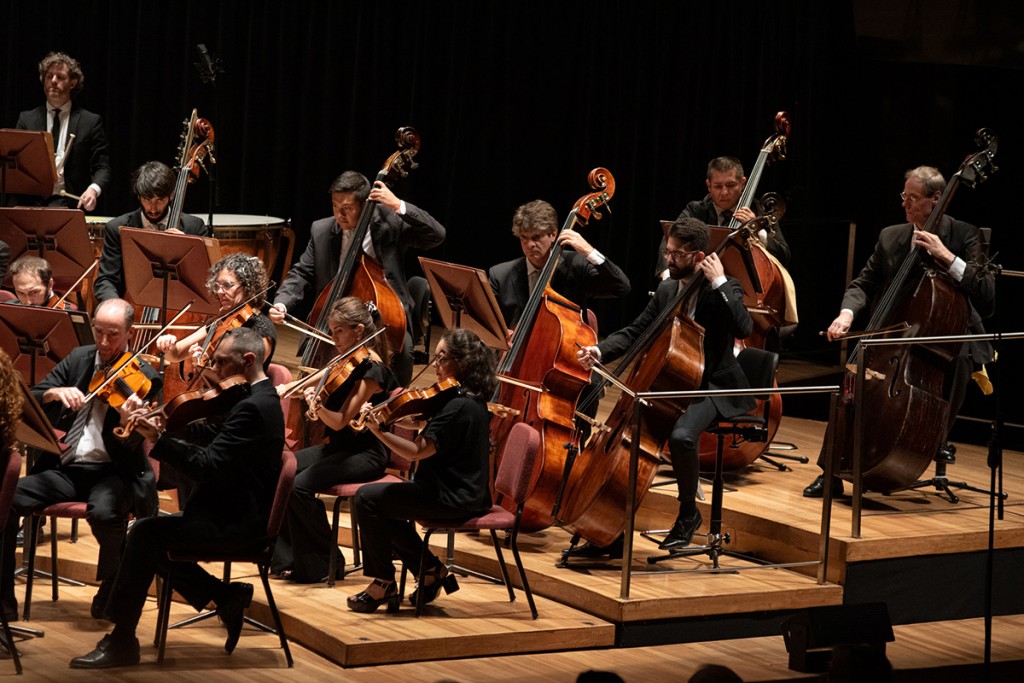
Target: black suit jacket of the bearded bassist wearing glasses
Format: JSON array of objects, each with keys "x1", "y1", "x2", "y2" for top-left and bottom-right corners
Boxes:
[{"x1": 597, "y1": 278, "x2": 755, "y2": 418}]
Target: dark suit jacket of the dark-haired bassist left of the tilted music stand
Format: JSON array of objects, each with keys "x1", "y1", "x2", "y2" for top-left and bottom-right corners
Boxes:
[{"x1": 273, "y1": 202, "x2": 444, "y2": 319}]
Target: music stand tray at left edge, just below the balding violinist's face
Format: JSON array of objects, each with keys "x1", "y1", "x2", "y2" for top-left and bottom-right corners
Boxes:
[{"x1": 0, "y1": 303, "x2": 93, "y2": 385}]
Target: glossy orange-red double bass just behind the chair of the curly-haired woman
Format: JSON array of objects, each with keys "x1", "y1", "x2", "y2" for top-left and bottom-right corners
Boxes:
[{"x1": 490, "y1": 168, "x2": 615, "y2": 531}]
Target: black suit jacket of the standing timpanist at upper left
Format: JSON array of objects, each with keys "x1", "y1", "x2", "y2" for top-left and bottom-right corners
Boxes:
[{"x1": 17, "y1": 102, "x2": 111, "y2": 208}]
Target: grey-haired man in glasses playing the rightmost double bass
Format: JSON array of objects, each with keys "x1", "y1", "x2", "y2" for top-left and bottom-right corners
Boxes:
[{"x1": 804, "y1": 166, "x2": 995, "y2": 498}]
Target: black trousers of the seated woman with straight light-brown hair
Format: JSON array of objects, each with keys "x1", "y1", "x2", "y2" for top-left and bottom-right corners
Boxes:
[{"x1": 272, "y1": 443, "x2": 387, "y2": 583}]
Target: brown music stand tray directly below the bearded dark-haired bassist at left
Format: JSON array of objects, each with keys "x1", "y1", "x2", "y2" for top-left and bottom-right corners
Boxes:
[{"x1": 121, "y1": 227, "x2": 220, "y2": 322}]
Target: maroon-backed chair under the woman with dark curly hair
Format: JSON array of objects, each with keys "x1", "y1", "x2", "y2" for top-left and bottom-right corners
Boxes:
[{"x1": 416, "y1": 422, "x2": 541, "y2": 618}]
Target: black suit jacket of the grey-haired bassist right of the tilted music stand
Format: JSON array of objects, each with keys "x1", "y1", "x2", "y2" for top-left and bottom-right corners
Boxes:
[{"x1": 487, "y1": 251, "x2": 630, "y2": 328}]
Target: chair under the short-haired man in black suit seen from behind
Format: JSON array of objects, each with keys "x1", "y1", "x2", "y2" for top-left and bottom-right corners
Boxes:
[{"x1": 156, "y1": 451, "x2": 295, "y2": 667}]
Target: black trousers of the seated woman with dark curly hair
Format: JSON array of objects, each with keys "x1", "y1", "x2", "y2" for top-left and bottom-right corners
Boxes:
[{"x1": 354, "y1": 481, "x2": 473, "y2": 581}]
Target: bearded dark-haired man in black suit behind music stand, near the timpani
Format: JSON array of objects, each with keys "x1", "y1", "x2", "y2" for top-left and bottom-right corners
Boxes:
[{"x1": 95, "y1": 161, "x2": 210, "y2": 301}]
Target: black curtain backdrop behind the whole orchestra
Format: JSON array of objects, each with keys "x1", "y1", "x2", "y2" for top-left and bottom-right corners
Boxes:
[{"x1": 0, "y1": 0, "x2": 1024, "y2": 448}]
